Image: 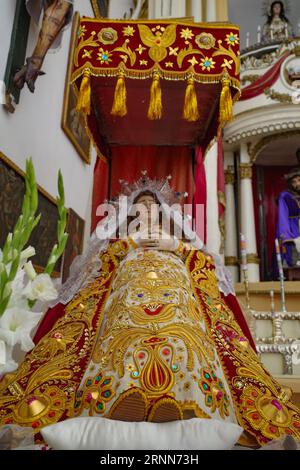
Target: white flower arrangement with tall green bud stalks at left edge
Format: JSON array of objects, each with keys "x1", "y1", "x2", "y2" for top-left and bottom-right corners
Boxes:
[{"x1": 0, "y1": 159, "x2": 68, "y2": 380}]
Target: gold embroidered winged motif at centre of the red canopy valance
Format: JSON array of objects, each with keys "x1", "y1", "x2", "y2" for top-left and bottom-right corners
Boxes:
[{"x1": 138, "y1": 23, "x2": 176, "y2": 63}]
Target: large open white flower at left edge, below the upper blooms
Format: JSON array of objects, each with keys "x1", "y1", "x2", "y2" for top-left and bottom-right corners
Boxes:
[{"x1": 0, "y1": 307, "x2": 43, "y2": 352}]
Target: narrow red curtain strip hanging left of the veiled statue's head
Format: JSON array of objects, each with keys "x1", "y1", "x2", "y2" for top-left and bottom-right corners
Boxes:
[{"x1": 91, "y1": 156, "x2": 109, "y2": 232}]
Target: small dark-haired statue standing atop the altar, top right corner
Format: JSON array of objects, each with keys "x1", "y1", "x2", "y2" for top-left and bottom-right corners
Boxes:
[{"x1": 262, "y1": 1, "x2": 293, "y2": 42}]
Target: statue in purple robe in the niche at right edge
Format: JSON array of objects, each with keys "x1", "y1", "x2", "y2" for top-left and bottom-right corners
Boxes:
[{"x1": 276, "y1": 149, "x2": 300, "y2": 266}]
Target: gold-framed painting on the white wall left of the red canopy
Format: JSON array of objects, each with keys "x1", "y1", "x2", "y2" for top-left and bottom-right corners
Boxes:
[{"x1": 61, "y1": 12, "x2": 91, "y2": 163}]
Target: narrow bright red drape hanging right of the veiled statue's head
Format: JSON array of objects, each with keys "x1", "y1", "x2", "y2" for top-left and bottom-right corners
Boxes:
[{"x1": 194, "y1": 147, "x2": 206, "y2": 243}]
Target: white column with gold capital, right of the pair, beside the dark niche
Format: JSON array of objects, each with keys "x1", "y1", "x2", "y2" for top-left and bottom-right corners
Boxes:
[{"x1": 240, "y1": 143, "x2": 259, "y2": 282}]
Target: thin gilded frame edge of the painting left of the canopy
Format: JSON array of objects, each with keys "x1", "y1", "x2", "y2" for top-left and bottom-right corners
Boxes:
[{"x1": 61, "y1": 11, "x2": 92, "y2": 164}]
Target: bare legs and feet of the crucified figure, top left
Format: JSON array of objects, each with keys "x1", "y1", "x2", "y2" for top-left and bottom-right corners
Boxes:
[{"x1": 14, "y1": 0, "x2": 73, "y2": 93}]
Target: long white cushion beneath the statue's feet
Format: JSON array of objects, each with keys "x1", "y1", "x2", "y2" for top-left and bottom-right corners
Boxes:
[{"x1": 41, "y1": 417, "x2": 243, "y2": 450}]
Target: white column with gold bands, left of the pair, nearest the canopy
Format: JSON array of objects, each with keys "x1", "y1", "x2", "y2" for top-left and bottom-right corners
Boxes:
[{"x1": 225, "y1": 152, "x2": 239, "y2": 282}]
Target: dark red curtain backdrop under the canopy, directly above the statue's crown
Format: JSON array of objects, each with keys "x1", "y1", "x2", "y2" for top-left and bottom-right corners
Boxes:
[{"x1": 110, "y1": 146, "x2": 194, "y2": 203}]
